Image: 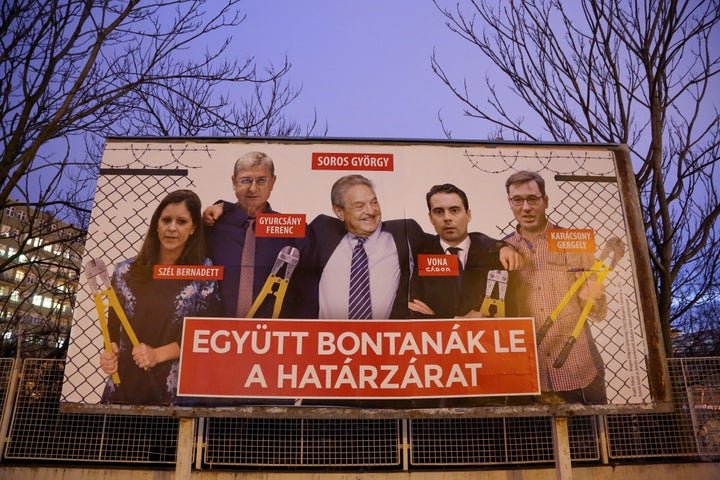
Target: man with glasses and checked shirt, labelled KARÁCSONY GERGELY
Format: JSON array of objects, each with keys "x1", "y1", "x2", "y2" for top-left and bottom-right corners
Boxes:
[{"x1": 504, "y1": 171, "x2": 607, "y2": 404}]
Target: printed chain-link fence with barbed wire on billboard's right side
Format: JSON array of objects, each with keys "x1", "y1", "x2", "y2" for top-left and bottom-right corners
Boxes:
[{"x1": 478, "y1": 152, "x2": 650, "y2": 405}]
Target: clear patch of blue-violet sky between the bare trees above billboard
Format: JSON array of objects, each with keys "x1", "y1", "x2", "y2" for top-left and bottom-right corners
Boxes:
[{"x1": 232, "y1": 0, "x2": 491, "y2": 140}]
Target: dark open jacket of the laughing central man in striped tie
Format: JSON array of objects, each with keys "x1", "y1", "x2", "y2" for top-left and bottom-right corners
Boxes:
[{"x1": 288, "y1": 215, "x2": 427, "y2": 318}]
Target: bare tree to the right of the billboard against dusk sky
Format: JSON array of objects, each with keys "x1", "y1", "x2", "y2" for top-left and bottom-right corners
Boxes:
[{"x1": 432, "y1": 0, "x2": 720, "y2": 352}]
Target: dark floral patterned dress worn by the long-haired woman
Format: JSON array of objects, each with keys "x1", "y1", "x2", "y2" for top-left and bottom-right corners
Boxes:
[{"x1": 102, "y1": 259, "x2": 222, "y2": 405}]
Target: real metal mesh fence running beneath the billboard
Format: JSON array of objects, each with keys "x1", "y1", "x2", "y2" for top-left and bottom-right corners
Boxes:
[{"x1": 0, "y1": 357, "x2": 720, "y2": 470}]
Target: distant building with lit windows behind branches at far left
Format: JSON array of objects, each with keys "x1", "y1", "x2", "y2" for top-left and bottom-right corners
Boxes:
[{"x1": 0, "y1": 201, "x2": 84, "y2": 357}]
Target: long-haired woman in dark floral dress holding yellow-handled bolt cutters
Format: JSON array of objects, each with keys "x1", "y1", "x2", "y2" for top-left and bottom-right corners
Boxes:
[{"x1": 100, "y1": 190, "x2": 221, "y2": 405}]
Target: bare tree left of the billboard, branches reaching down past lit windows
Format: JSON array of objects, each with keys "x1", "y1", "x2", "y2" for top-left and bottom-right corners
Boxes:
[{"x1": 0, "y1": 0, "x2": 316, "y2": 356}]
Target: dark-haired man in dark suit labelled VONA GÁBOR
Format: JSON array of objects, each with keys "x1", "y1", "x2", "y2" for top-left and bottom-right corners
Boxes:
[{"x1": 408, "y1": 183, "x2": 520, "y2": 318}]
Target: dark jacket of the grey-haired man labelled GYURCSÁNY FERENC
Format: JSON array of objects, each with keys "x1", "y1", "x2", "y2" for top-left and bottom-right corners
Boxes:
[{"x1": 207, "y1": 202, "x2": 296, "y2": 318}]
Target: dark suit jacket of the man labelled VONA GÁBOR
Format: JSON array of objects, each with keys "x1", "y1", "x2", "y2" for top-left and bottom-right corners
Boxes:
[{"x1": 410, "y1": 232, "x2": 508, "y2": 318}]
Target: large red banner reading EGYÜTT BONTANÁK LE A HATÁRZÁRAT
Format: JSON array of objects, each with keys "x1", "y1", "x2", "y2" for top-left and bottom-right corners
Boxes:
[{"x1": 178, "y1": 318, "x2": 540, "y2": 399}]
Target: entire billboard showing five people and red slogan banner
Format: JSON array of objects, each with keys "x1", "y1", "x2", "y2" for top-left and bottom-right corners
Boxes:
[{"x1": 62, "y1": 138, "x2": 669, "y2": 415}]
